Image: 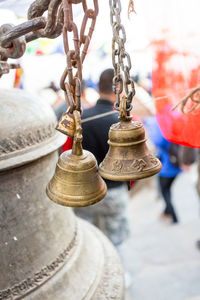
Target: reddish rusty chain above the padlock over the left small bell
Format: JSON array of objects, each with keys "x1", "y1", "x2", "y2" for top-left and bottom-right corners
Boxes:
[{"x1": 60, "y1": 0, "x2": 98, "y2": 113}]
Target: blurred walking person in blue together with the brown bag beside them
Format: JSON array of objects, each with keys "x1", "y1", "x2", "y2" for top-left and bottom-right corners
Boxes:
[{"x1": 145, "y1": 117, "x2": 197, "y2": 223}]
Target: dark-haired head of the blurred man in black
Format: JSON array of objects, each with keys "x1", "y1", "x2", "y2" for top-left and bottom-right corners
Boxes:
[{"x1": 99, "y1": 69, "x2": 116, "y2": 102}]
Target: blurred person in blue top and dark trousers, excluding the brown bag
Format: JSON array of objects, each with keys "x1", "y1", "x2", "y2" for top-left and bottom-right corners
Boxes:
[{"x1": 144, "y1": 117, "x2": 182, "y2": 223}]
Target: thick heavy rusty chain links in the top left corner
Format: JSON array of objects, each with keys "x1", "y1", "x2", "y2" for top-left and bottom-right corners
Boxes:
[{"x1": 0, "y1": 0, "x2": 63, "y2": 77}]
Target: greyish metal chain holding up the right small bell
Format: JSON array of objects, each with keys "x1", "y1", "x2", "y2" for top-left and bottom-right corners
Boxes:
[{"x1": 109, "y1": 0, "x2": 135, "y2": 115}]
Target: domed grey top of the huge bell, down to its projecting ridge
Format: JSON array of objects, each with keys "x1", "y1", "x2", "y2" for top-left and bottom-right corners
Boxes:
[{"x1": 0, "y1": 89, "x2": 66, "y2": 170}]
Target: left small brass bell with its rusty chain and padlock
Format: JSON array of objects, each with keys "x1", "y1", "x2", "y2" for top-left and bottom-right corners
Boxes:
[{"x1": 47, "y1": 0, "x2": 107, "y2": 207}]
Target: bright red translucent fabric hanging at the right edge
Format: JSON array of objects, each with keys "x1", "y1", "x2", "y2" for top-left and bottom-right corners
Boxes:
[{"x1": 152, "y1": 40, "x2": 200, "y2": 148}]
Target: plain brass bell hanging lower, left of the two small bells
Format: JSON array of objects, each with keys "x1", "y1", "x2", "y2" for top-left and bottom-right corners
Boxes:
[{"x1": 46, "y1": 150, "x2": 107, "y2": 207}]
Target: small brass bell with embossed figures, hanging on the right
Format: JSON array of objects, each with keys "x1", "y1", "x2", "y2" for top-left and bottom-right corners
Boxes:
[{"x1": 99, "y1": 120, "x2": 162, "y2": 181}]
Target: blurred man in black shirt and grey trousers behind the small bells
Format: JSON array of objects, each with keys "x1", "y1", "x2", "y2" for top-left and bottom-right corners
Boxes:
[{"x1": 75, "y1": 69, "x2": 129, "y2": 247}]
